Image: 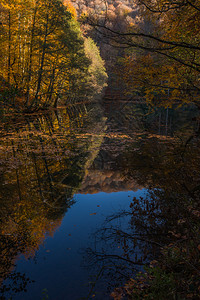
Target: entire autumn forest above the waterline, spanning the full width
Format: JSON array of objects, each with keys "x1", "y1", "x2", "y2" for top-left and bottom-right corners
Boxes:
[{"x1": 0, "y1": 0, "x2": 200, "y2": 111}]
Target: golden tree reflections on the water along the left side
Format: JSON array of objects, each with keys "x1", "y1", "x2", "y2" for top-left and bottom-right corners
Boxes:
[{"x1": 0, "y1": 102, "x2": 103, "y2": 298}]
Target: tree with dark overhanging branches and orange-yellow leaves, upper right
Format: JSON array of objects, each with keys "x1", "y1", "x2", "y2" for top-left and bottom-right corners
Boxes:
[{"x1": 87, "y1": 0, "x2": 200, "y2": 106}]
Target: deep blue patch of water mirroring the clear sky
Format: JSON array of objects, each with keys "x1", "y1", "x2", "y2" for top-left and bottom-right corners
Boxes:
[{"x1": 13, "y1": 191, "x2": 143, "y2": 299}]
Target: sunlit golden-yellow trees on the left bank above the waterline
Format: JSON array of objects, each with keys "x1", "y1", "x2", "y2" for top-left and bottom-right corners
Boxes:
[{"x1": 0, "y1": 0, "x2": 107, "y2": 110}]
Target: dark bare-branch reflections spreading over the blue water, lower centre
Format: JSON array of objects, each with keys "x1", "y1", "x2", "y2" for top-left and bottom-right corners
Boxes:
[{"x1": 84, "y1": 193, "x2": 158, "y2": 295}]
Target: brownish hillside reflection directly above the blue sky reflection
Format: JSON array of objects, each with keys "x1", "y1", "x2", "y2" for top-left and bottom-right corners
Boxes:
[{"x1": 79, "y1": 144, "x2": 142, "y2": 194}]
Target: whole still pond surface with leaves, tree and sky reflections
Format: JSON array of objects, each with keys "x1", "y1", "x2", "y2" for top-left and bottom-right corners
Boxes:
[{"x1": 0, "y1": 103, "x2": 200, "y2": 300}]
